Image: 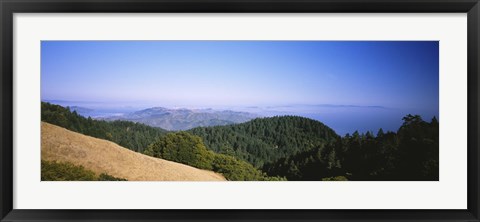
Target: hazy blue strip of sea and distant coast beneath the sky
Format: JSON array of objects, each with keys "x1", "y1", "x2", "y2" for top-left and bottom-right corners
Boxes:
[{"x1": 45, "y1": 100, "x2": 439, "y2": 136}]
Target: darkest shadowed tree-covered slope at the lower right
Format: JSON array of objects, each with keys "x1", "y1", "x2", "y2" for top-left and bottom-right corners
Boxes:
[{"x1": 263, "y1": 115, "x2": 439, "y2": 181}]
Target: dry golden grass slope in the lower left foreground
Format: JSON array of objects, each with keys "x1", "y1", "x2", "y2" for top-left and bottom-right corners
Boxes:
[{"x1": 42, "y1": 122, "x2": 225, "y2": 181}]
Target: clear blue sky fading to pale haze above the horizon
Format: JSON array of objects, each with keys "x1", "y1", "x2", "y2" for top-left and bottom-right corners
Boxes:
[{"x1": 41, "y1": 41, "x2": 439, "y2": 134}]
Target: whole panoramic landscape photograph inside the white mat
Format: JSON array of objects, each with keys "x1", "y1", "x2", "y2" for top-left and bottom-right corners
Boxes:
[{"x1": 41, "y1": 40, "x2": 438, "y2": 183}]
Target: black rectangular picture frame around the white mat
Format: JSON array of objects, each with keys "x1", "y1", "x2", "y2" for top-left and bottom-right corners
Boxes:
[{"x1": 0, "y1": 0, "x2": 480, "y2": 221}]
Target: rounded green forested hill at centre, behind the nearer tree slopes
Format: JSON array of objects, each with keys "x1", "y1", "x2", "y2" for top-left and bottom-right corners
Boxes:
[{"x1": 188, "y1": 116, "x2": 339, "y2": 167}]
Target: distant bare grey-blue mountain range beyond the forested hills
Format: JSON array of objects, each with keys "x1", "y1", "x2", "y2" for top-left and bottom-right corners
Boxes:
[{"x1": 101, "y1": 107, "x2": 259, "y2": 131}]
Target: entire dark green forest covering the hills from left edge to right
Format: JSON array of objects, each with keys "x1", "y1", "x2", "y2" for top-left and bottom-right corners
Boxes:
[{"x1": 42, "y1": 103, "x2": 439, "y2": 181}]
